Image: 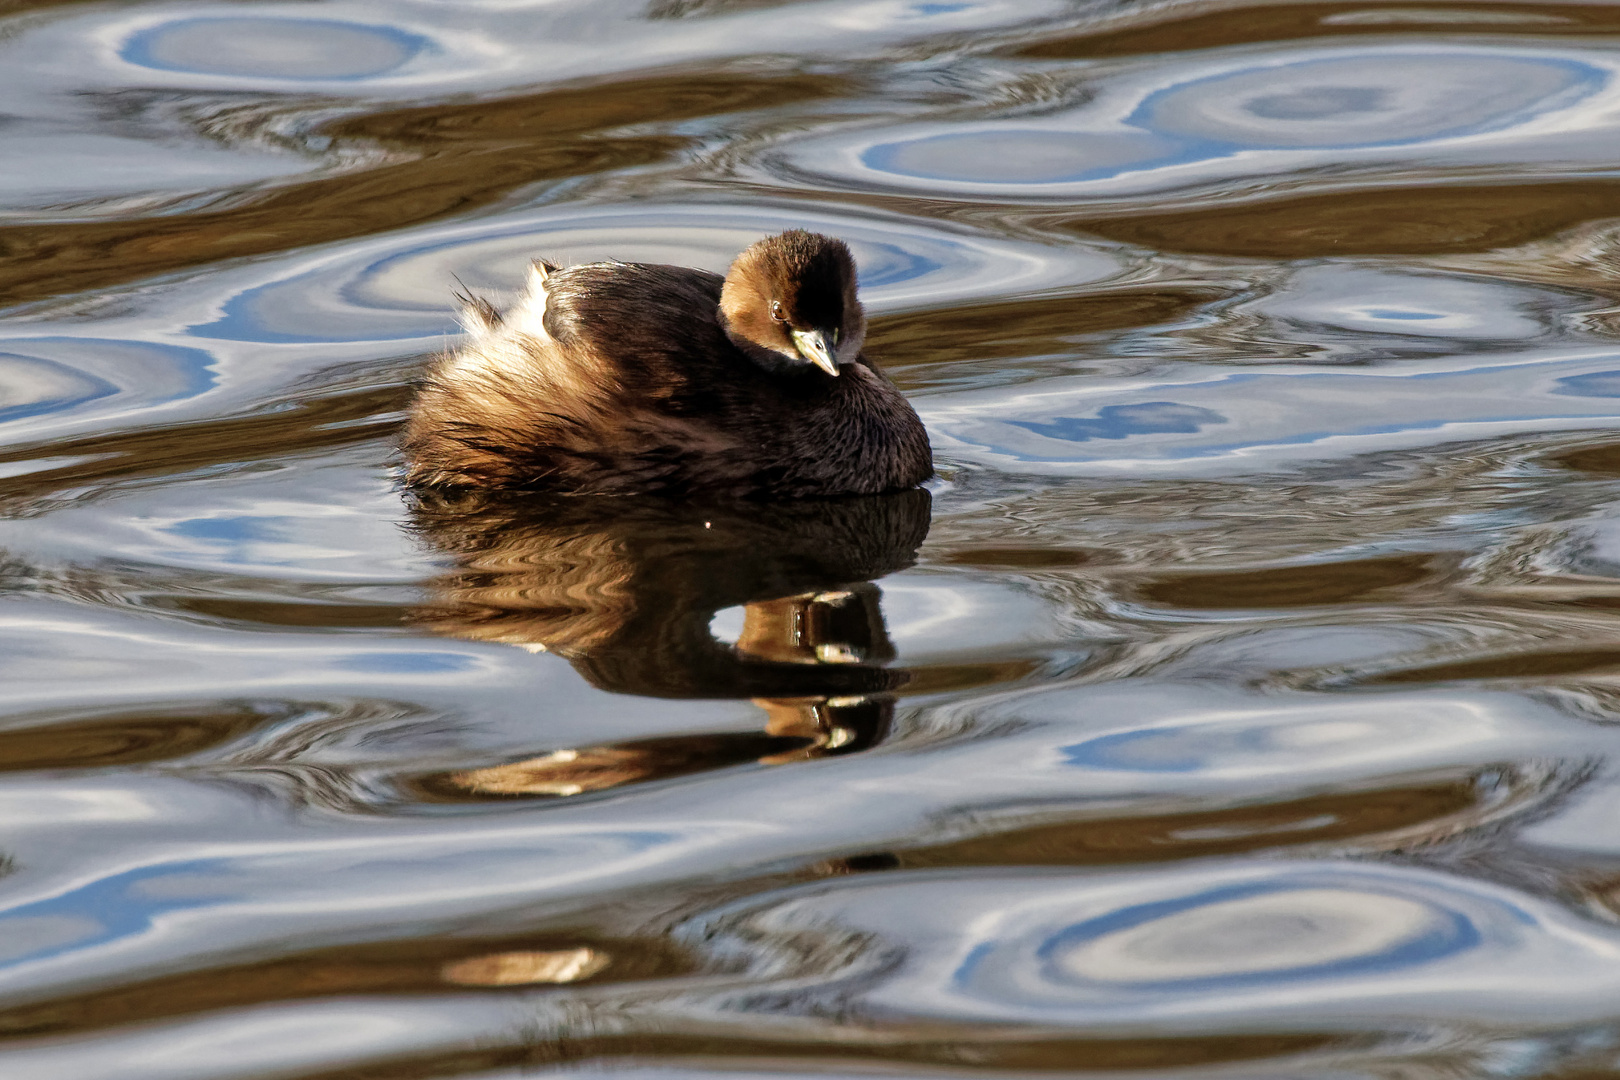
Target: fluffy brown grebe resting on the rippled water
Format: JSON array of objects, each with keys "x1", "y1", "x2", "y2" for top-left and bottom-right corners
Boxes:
[{"x1": 403, "y1": 230, "x2": 933, "y2": 499}]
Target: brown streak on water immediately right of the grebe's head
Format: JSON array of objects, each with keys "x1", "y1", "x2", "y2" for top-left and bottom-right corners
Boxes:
[{"x1": 867, "y1": 288, "x2": 1221, "y2": 375}]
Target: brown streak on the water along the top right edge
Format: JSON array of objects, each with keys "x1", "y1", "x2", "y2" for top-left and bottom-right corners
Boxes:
[{"x1": 1017, "y1": 0, "x2": 1620, "y2": 60}]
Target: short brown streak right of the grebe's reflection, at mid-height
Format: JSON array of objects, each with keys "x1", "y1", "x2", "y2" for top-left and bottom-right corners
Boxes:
[{"x1": 1137, "y1": 555, "x2": 1455, "y2": 609}]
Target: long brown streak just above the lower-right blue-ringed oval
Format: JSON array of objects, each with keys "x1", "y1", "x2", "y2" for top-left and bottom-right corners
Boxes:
[{"x1": 834, "y1": 777, "x2": 1479, "y2": 871}]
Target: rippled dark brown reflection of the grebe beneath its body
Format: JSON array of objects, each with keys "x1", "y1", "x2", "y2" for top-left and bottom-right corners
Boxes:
[{"x1": 413, "y1": 491, "x2": 930, "y2": 800}]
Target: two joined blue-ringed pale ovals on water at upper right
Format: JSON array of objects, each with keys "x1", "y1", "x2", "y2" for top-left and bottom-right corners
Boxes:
[{"x1": 781, "y1": 44, "x2": 1615, "y2": 201}]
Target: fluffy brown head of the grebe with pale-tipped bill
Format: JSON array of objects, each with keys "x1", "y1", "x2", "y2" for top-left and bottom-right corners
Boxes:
[{"x1": 719, "y1": 228, "x2": 867, "y2": 376}]
